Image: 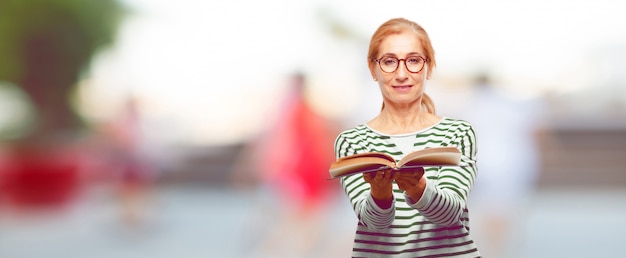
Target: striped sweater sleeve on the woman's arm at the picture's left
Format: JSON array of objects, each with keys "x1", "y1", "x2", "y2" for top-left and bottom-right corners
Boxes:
[{"x1": 335, "y1": 134, "x2": 395, "y2": 230}]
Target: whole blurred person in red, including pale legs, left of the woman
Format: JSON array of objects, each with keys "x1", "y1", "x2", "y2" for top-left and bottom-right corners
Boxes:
[{"x1": 232, "y1": 73, "x2": 338, "y2": 257}]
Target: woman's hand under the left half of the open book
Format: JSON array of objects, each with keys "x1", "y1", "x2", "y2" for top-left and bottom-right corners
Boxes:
[{"x1": 363, "y1": 169, "x2": 393, "y2": 209}]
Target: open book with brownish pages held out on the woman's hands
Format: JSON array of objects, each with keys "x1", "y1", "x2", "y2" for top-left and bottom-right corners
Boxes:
[{"x1": 329, "y1": 147, "x2": 461, "y2": 178}]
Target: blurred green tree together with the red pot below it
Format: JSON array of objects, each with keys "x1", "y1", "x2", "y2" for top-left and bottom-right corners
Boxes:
[{"x1": 0, "y1": 0, "x2": 123, "y2": 209}]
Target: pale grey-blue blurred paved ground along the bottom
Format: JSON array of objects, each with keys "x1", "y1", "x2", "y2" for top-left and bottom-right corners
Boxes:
[{"x1": 0, "y1": 184, "x2": 626, "y2": 258}]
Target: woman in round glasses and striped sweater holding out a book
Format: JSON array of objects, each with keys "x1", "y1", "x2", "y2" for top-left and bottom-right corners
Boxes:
[{"x1": 335, "y1": 18, "x2": 480, "y2": 257}]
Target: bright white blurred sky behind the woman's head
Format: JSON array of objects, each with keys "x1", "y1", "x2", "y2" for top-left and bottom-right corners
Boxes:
[{"x1": 81, "y1": 0, "x2": 626, "y2": 144}]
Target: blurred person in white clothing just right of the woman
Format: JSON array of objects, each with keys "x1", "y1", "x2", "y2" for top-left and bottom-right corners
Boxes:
[{"x1": 461, "y1": 73, "x2": 544, "y2": 257}]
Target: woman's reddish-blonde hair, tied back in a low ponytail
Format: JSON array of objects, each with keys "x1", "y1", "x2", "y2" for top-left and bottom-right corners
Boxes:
[{"x1": 367, "y1": 18, "x2": 436, "y2": 114}]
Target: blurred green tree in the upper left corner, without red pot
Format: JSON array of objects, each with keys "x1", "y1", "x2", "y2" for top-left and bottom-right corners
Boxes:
[{"x1": 0, "y1": 0, "x2": 123, "y2": 142}]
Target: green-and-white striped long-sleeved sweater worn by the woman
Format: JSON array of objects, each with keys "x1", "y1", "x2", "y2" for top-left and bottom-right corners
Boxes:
[{"x1": 335, "y1": 118, "x2": 480, "y2": 257}]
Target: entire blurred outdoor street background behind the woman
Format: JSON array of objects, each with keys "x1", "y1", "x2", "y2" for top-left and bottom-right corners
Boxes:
[{"x1": 0, "y1": 0, "x2": 626, "y2": 258}]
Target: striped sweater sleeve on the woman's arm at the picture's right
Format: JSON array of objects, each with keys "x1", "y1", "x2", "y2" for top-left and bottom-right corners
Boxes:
[{"x1": 411, "y1": 126, "x2": 477, "y2": 225}]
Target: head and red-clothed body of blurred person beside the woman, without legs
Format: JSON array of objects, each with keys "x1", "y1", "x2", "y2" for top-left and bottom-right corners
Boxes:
[{"x1": 260, "y1": 73, "x2": 334, "y2": 208}]
